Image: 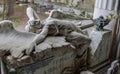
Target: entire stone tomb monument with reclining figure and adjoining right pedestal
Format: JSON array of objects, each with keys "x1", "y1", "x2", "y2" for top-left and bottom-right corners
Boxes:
[{"x1": 0, "y1": 3, "x2": 112, "y2": 74}]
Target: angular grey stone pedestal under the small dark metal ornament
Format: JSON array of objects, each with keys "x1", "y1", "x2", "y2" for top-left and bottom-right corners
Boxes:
[{"x1": 88, "y1": 28, "x2": 112, "y2": 72}]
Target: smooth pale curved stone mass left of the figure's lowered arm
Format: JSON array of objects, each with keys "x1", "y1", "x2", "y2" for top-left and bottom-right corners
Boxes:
[{"x1": 0, "y1": 21, "x2": 36, "y2": 58}]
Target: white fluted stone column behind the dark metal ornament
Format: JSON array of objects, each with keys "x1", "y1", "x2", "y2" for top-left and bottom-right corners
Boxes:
[{"x1": 93, "y1": 0, "x2": 118, "y2": 18}]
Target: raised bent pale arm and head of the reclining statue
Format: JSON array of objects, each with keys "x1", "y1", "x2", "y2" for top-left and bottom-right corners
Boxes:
[{"x1": 25, "y1": 5, "x2": 41, "y2": 33}]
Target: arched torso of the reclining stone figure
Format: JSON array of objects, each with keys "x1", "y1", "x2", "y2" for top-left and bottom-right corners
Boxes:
[{"x1": 43, "y1": 19, "x2": 83, "y2": 35}]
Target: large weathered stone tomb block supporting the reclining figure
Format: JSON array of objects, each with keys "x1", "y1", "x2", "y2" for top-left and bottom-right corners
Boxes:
[{"x1": 7, "y1": 36, "x2": 90, "y2": 74}]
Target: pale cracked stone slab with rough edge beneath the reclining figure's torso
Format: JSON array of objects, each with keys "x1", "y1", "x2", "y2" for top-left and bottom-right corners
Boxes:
[{"x1": 34, "y1": 37, "x2": 73, "y2": 60}]
